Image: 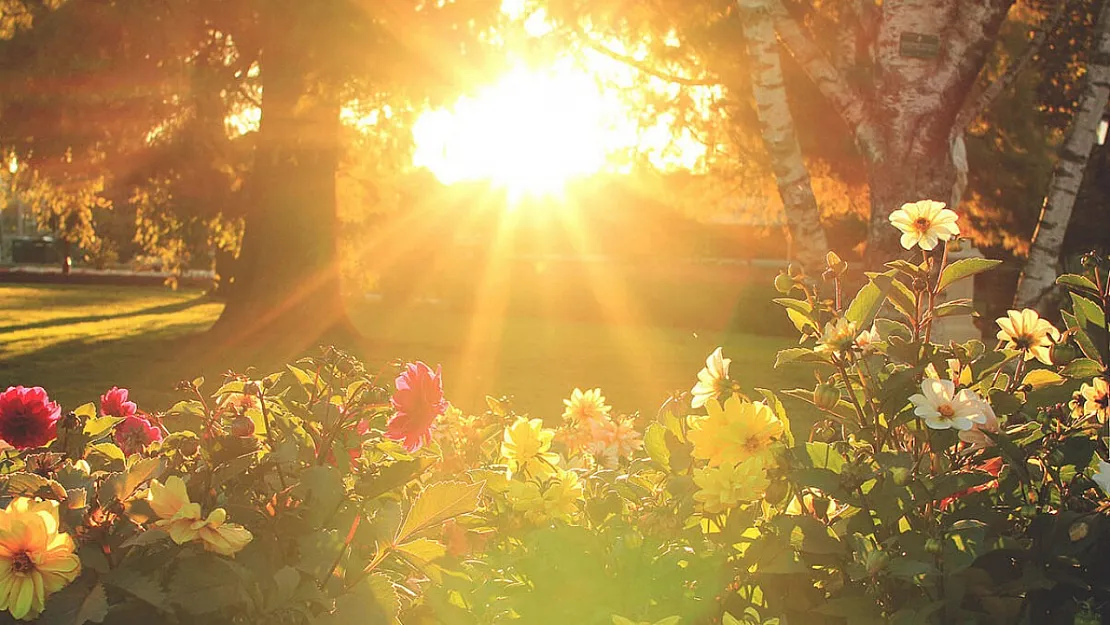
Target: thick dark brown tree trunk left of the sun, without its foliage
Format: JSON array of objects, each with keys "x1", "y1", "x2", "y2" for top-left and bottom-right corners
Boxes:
[{"x1": 215, "y1": 2, "x2": 350, "y2": 351}]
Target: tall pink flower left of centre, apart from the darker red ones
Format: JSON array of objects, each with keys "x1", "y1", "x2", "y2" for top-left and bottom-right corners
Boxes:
[{"x1": 385, "y1": 362, "x2": 447, "y2": 452}]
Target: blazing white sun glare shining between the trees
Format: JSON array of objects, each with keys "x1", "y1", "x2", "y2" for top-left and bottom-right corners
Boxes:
[{"x1": 413, "y1": 61, "x2": 636, "y2": 198}]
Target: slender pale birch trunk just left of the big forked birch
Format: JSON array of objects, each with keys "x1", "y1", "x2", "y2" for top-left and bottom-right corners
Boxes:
[{"x1": 738, "y1": 0, "x2": 828, "y2": 270}]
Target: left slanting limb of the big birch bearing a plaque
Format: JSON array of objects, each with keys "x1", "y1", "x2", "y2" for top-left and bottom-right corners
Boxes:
[{"x1": 770, "y1": 0, "x2": 882, "y2": 162}]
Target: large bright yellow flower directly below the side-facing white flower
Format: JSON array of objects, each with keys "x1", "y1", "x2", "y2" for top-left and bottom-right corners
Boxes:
[{"x1": 688, "y1": 395, "x2": 783, "y2": 466}]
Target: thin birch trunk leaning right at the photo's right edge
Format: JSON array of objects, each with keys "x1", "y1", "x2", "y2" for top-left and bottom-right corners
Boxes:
[{"x1": 1013, "y1": 2, "x2": 1110, "y2": 309}]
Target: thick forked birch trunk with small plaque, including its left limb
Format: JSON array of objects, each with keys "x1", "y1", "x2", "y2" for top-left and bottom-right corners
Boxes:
[{"x1": 771, "y1": 0, "x2": 1013, "y2": 266}]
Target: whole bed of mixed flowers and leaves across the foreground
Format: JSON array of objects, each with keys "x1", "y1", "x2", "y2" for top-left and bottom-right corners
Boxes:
[{"x1": 0, "y1": 202, "x2": 1110, "y2": 625}]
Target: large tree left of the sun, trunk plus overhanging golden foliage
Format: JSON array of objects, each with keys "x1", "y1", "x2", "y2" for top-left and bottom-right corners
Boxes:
[{"x1": 0, "y1": 0, "x2": 497, "y2": 353}]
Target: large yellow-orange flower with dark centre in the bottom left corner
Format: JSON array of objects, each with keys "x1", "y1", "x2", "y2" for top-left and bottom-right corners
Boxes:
[{"x1": 0, "y1": 497, "x2": 81, "y2": 621}]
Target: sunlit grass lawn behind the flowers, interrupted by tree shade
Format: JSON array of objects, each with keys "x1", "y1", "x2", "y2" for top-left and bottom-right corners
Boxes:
[{"x1": 0, "y1": 284, "x2": 811, "y2": 419}]
